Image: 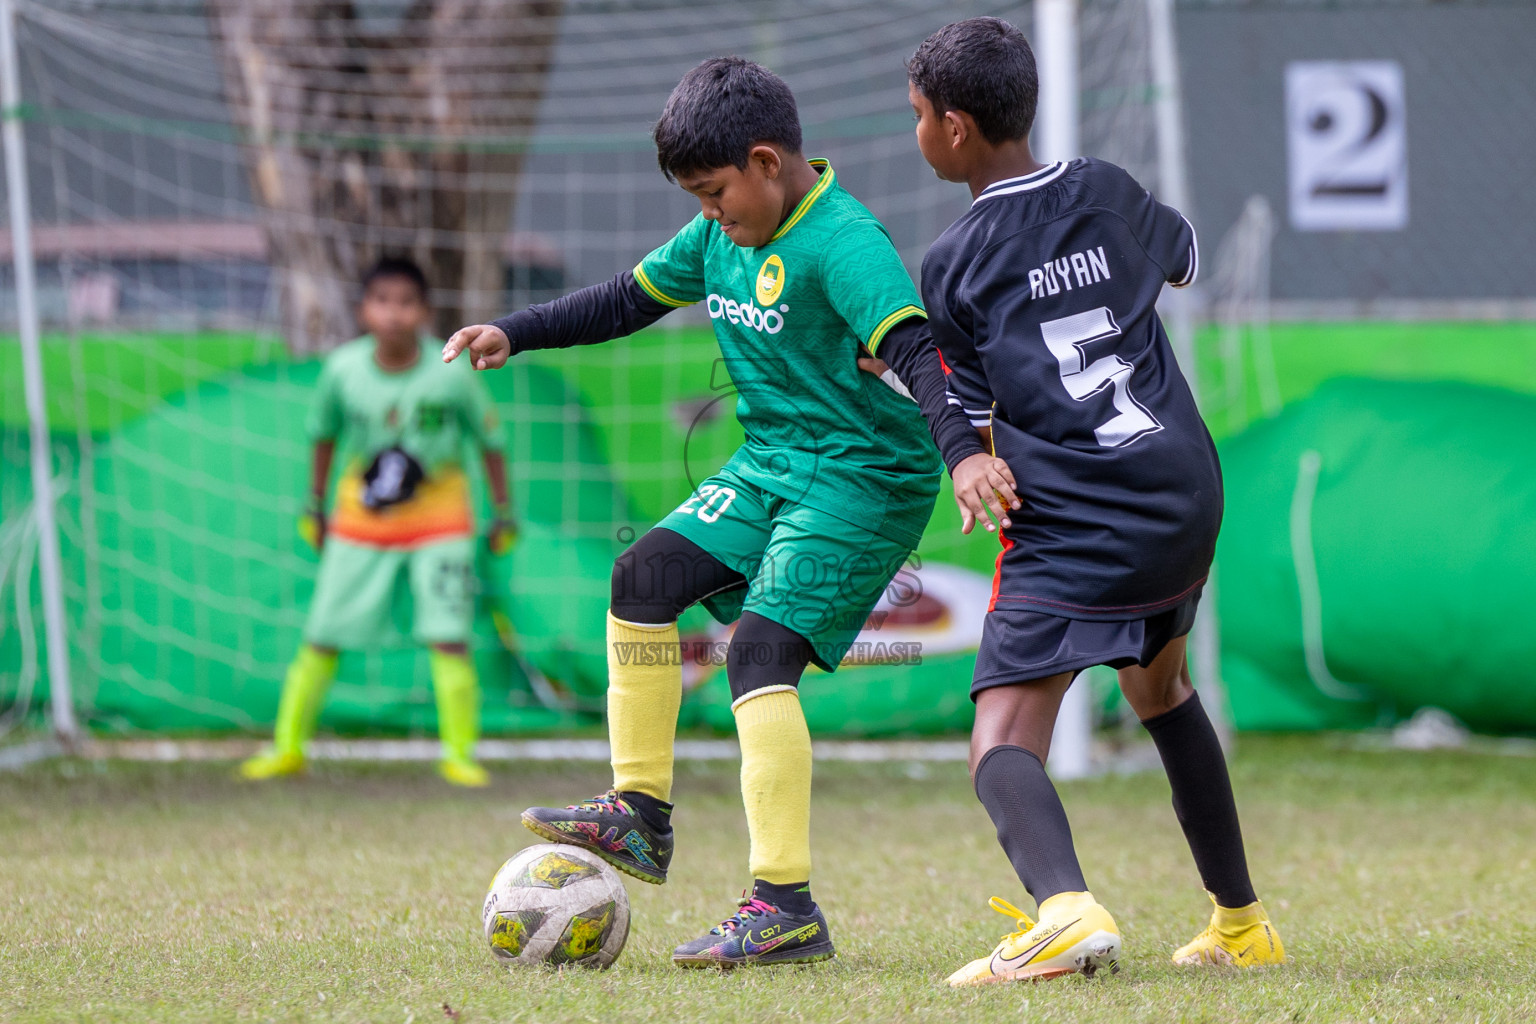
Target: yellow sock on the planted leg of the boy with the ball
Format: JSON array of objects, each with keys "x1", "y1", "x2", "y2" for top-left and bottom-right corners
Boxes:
[{"x1": 731, "y1": 686, "x2": 811, "y2": 886}]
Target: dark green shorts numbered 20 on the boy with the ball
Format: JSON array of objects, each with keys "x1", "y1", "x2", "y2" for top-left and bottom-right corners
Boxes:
[{"x1": 656, "y1": 470, "x2": 912, "y2": 672}]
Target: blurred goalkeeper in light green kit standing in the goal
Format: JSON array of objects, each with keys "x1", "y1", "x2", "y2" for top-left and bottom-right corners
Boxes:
[{"x1": 240, "y1": 256, "x2": 516, "y2": 786}]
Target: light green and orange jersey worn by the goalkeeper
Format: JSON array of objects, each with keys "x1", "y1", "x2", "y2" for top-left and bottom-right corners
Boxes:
[{"x1": 309, "y1": 336, "x2": 504, "y2": 548}]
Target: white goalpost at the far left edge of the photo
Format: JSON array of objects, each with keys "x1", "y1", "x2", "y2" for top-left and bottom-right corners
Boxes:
[{"x1": 0, "y1": 0, "x2": 80, "y2": 745}]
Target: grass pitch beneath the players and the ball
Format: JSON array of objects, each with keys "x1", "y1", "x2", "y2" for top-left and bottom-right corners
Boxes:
[{"x1": 0, "y1": 738, "x2": 1536, "y2": 1024}]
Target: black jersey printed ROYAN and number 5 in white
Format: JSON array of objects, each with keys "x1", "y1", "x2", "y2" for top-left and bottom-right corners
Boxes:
[{"x1": 923, "y1": 160, "x2": 1221, "y2": 619}]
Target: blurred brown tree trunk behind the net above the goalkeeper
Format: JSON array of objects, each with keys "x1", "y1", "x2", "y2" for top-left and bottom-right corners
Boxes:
[{"x1": 209, "y1": 0, "x2": 562, "y2": 353}]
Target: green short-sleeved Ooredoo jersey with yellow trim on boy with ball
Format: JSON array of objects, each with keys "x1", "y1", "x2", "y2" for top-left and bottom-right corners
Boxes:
[{"x1": 634, "y1": 160, "x2": 940, "y2": 545}]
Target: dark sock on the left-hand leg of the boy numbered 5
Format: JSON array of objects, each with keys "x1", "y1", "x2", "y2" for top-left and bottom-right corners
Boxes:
[{"x1": 975, "y1": 746, "x2": 1087, "y2": 903}]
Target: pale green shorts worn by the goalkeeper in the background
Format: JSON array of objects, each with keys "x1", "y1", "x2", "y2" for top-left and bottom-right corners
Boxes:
[{"x1": 304, "y1": 537, "x2": 478, "y2": 651}]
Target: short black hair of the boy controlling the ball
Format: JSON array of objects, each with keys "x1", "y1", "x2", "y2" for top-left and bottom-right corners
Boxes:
[{"x1": 651, "y1": 57, "x2": 800, "y2": 181}]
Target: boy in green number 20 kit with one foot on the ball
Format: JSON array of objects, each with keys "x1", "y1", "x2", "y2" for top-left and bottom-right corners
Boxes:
[{"x1": 442, "y1": 57, "x2": 1012, "y2": 967}]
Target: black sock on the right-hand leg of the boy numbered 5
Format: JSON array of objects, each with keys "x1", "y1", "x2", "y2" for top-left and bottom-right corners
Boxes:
[{"x1": 1141, "y1": 694, "x2": 1258, "y2": 909}]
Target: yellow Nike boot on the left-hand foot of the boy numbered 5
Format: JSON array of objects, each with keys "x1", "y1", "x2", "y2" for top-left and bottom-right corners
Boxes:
[{"x1": 949, "y1": 892, "x2": 1120, "y2": 989}]
